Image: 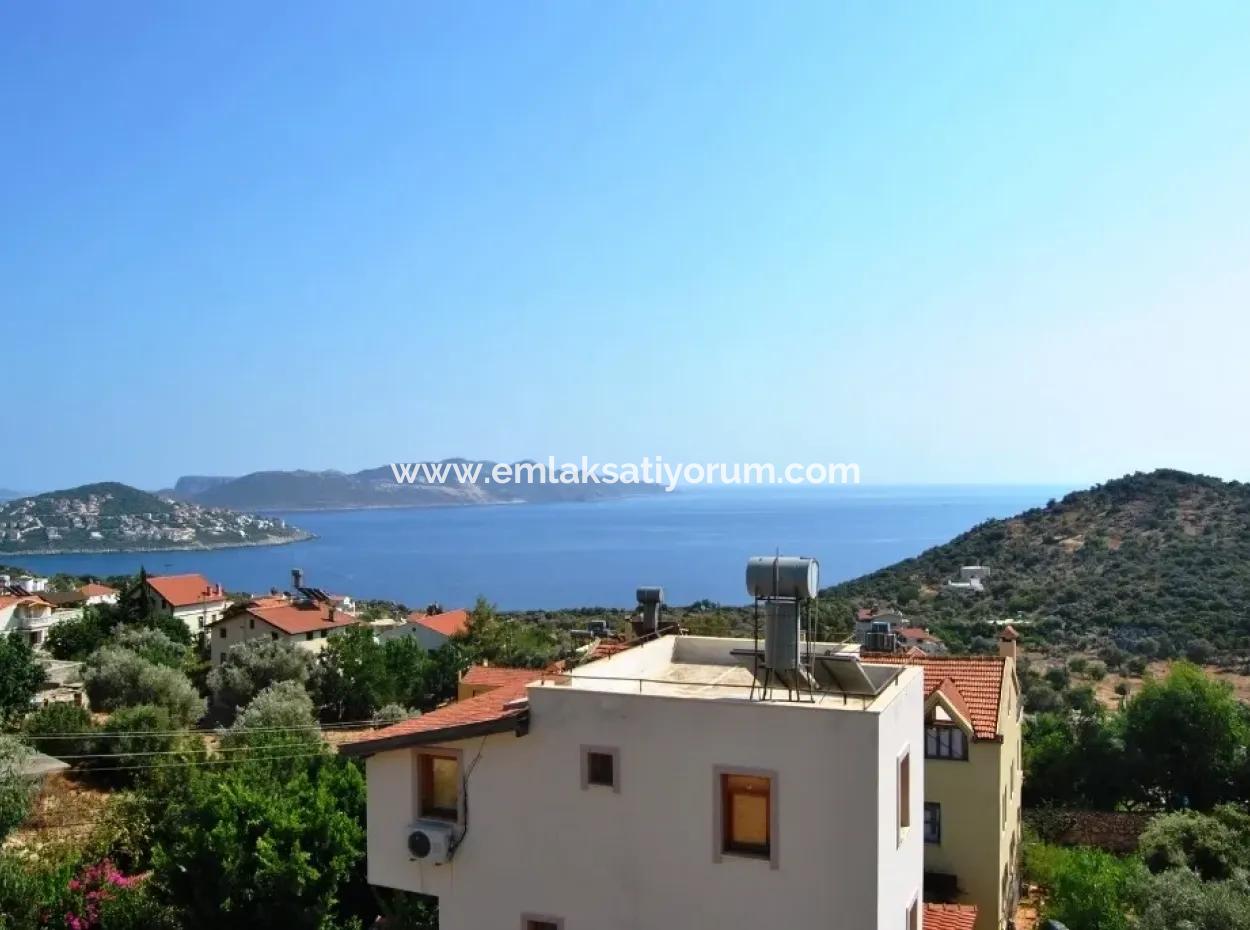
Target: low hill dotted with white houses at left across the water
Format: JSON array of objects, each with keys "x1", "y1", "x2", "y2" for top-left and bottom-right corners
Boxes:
[{"x1": 0, "y1": 481, "x2": 309, "y2": 553}]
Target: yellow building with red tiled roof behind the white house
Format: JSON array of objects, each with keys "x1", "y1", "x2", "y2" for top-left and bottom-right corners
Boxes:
[{"x1": 870, "y1": 626, "x2": 1024, "y2": 930}]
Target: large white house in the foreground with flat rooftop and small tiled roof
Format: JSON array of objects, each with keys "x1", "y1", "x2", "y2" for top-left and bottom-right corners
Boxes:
[{"x1": 343, "y1": 636, "x2": 930, "y2": 930}]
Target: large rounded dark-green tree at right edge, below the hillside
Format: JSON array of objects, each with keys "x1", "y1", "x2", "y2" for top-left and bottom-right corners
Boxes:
[{"x1": 1124, "y1": 663, "x2": 1248, "y2": 810}]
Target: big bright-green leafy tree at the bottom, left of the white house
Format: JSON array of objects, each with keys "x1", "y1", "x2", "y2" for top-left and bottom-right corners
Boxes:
[{"x1": 151, "y1": 756, "x2": 365, "y2": 930}]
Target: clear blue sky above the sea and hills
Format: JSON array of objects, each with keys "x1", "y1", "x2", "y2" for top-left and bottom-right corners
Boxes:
[{"x1": 0, "y1": 0, "x2": 1250, "y2": 490}]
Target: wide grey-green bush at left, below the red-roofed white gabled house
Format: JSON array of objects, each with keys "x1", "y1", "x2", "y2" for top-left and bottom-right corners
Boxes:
[{"x1": 83, "y1": 646, "x2": 205, "y2": 726}]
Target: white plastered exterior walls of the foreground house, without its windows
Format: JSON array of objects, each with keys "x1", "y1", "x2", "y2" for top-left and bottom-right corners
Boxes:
[{"x1": 366, "y1": 665, "x2": 924, "y2": 930}]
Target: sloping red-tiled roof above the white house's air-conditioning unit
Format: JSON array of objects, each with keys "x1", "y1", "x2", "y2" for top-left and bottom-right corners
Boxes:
[{"x1": 339, "y1": 669, "x2": 543, "y2": 756}]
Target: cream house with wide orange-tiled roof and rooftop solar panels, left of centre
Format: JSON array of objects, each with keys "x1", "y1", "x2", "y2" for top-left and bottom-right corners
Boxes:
[{"x1": 208, "y1": 595, "x2": 359, "y2": 665}]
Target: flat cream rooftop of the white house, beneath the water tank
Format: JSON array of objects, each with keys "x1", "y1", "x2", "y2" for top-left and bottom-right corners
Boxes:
[{"x1": 535, "y1": 636, "x2": 908, "y2": 710}]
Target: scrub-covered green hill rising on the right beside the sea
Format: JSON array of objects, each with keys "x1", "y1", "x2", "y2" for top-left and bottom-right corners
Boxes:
[{"x1": 823, "y1": 470, "x2": 1250, "y2": 656}]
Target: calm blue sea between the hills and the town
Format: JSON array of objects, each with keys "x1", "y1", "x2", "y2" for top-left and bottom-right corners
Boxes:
[{"x1": 9, "y1": 486, "x2": 1069, "y2": 609}]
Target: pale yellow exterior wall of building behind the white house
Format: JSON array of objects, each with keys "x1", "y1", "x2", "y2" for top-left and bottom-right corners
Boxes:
[{"x1": 925, "y1": 659, "x2": 1023, "y2": 930}]
